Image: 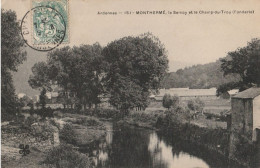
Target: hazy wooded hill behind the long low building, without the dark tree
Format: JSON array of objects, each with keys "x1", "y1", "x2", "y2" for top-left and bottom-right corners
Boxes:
[{"x1": 161, "y1": 60, "x2": 239, "y2": 89}]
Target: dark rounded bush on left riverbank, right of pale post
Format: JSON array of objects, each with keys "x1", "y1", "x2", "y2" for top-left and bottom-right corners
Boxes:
[{"x1": 60, "y1": 123, "x2": 76, "y2": 144}]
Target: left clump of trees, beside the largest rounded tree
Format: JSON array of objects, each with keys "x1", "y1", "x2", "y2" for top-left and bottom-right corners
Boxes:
[{"x1": 28, "y1": 43, "x2": 104, "y2": 108}]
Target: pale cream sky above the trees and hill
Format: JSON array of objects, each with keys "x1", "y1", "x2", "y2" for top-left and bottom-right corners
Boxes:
[{"x1": 2, "y1": 0, "x2": 260, "y2": 96}]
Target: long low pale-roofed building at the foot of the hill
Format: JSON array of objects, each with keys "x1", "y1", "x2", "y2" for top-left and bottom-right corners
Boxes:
[{"x1": 153, "y1": 88, "x2": 218, "y2": 101}]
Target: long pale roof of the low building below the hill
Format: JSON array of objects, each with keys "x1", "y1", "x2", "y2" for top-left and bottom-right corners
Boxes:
[{"x1": 156, "y1": 88, "x2": 217, "y2": 97}]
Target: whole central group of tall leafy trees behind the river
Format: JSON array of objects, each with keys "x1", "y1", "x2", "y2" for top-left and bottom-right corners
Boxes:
[{"x1": 28, "y1": 33, "x2": 168, "y2": 111}]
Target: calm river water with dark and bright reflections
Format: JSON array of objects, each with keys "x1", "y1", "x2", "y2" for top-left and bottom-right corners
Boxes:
[{"x1": 80, "y1": 123, "x2": 246, "y2": 168}]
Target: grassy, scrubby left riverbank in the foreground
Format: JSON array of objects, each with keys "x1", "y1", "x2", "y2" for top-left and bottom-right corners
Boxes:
[{"x1": 1, "y1": 112, "x2": 109, "y2": 168}]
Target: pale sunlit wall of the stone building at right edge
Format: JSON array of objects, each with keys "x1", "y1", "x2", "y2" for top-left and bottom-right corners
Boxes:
[{"x1": 253, "y1": 95, "x2": 260, "y2": 141}]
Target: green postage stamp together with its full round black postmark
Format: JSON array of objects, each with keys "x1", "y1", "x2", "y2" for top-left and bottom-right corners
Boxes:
[{"x1": 21, "y1": 0, "x2": 69, "y2": 51}]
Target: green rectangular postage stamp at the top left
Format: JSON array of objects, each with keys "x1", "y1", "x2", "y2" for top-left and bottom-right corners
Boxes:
[{"x1": 32, "y1": 0, "x2": 69, "y2": 45}]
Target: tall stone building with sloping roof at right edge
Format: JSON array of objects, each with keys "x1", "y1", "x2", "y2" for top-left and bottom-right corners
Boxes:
[{"x1": 231, "y1": 87, "x2": 260, "y2": 141}]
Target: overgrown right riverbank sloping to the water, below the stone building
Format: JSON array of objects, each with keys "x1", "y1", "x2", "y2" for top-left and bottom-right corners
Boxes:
[{"x1": 117, "y1": 111, "x2": 250, "y2": 167}]
